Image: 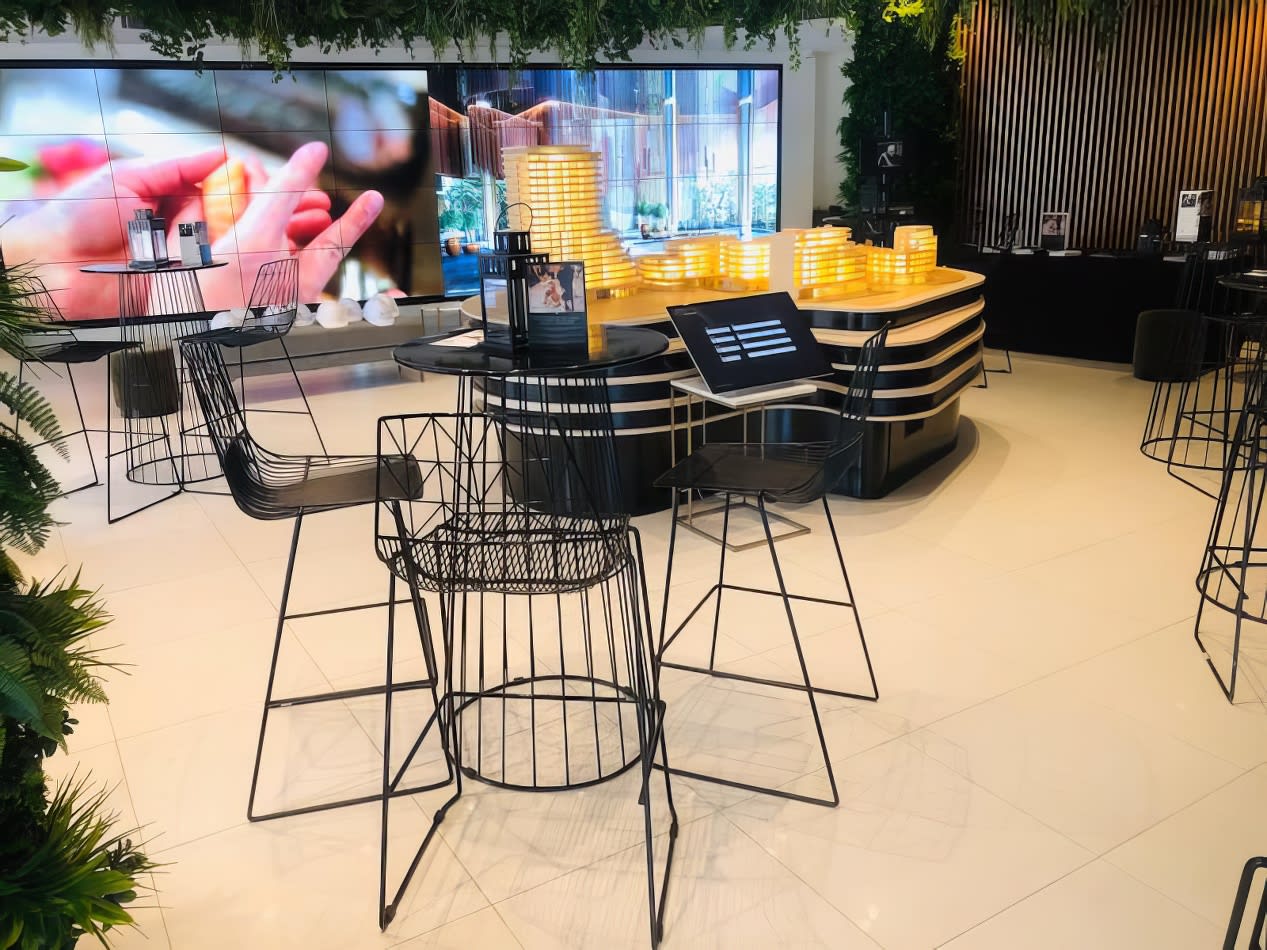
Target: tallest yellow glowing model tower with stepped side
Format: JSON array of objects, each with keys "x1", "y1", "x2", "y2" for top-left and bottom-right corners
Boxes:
[{"x1": 502, "y1": 146, "x2": 639, "y2": 291}]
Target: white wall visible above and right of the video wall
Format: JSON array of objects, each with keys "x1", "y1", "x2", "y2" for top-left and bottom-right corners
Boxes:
[{"x1": 0, "y1": 20, "x2": 853, "y2": 228}]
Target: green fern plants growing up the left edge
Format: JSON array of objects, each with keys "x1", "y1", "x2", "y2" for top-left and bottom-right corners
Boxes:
[{"x1": 0, "y1": 257, "x2": 153, "y2": 950}]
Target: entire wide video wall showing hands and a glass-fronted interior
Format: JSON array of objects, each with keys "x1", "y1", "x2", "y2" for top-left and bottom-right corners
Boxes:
[{"x1": 0, "y1": 66, "x2": 780, "y2": 319}]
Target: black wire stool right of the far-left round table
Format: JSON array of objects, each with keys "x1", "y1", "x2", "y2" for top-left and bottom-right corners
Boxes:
[{"x1": 188, "y1": 257, "x2": 327, "y2": 452}]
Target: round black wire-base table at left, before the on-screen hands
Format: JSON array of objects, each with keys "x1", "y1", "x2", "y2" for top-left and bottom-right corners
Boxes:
[{"x1": 80, "y1": 261, "x2": 227, "y2": 523}]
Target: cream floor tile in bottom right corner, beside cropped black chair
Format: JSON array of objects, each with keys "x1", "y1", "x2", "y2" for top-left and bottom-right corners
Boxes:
[{"x1": 1105, "y1": 766, "x2": 1267, "y2": 927}]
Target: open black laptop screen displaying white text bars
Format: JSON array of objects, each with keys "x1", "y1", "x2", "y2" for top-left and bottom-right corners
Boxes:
[{"x1": 669, "y1": 293, "x2": 831, "y2": 393}]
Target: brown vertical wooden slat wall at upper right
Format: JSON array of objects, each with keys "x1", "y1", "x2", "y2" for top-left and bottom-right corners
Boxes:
[{"x1": 959, "y1": 0, "x2": 1267, "y2": 248}]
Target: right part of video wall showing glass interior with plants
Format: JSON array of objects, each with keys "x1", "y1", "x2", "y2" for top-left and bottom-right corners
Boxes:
[{"x1": 430, "y1": 66, "x2": 780, "y2": 293}]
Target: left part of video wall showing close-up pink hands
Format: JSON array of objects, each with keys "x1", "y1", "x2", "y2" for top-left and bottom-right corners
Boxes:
[{"x1": 0, "y1": 67, "x2": 442, "y2": 319}]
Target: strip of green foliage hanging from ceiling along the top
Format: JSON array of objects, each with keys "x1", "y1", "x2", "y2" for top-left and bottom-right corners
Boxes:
[{"x1": 0, "y1": 0, "x2": 1130, "y2": 71}]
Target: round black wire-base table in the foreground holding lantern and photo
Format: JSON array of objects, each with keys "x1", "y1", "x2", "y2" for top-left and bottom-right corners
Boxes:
[{"x1": 379, "y1": 327, "x2": 668, "y2": 792}]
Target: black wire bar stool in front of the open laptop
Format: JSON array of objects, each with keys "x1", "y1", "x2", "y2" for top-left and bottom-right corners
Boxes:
[{"x1": 655, "y1": 324, "x2": 888, "y2": 806}]
